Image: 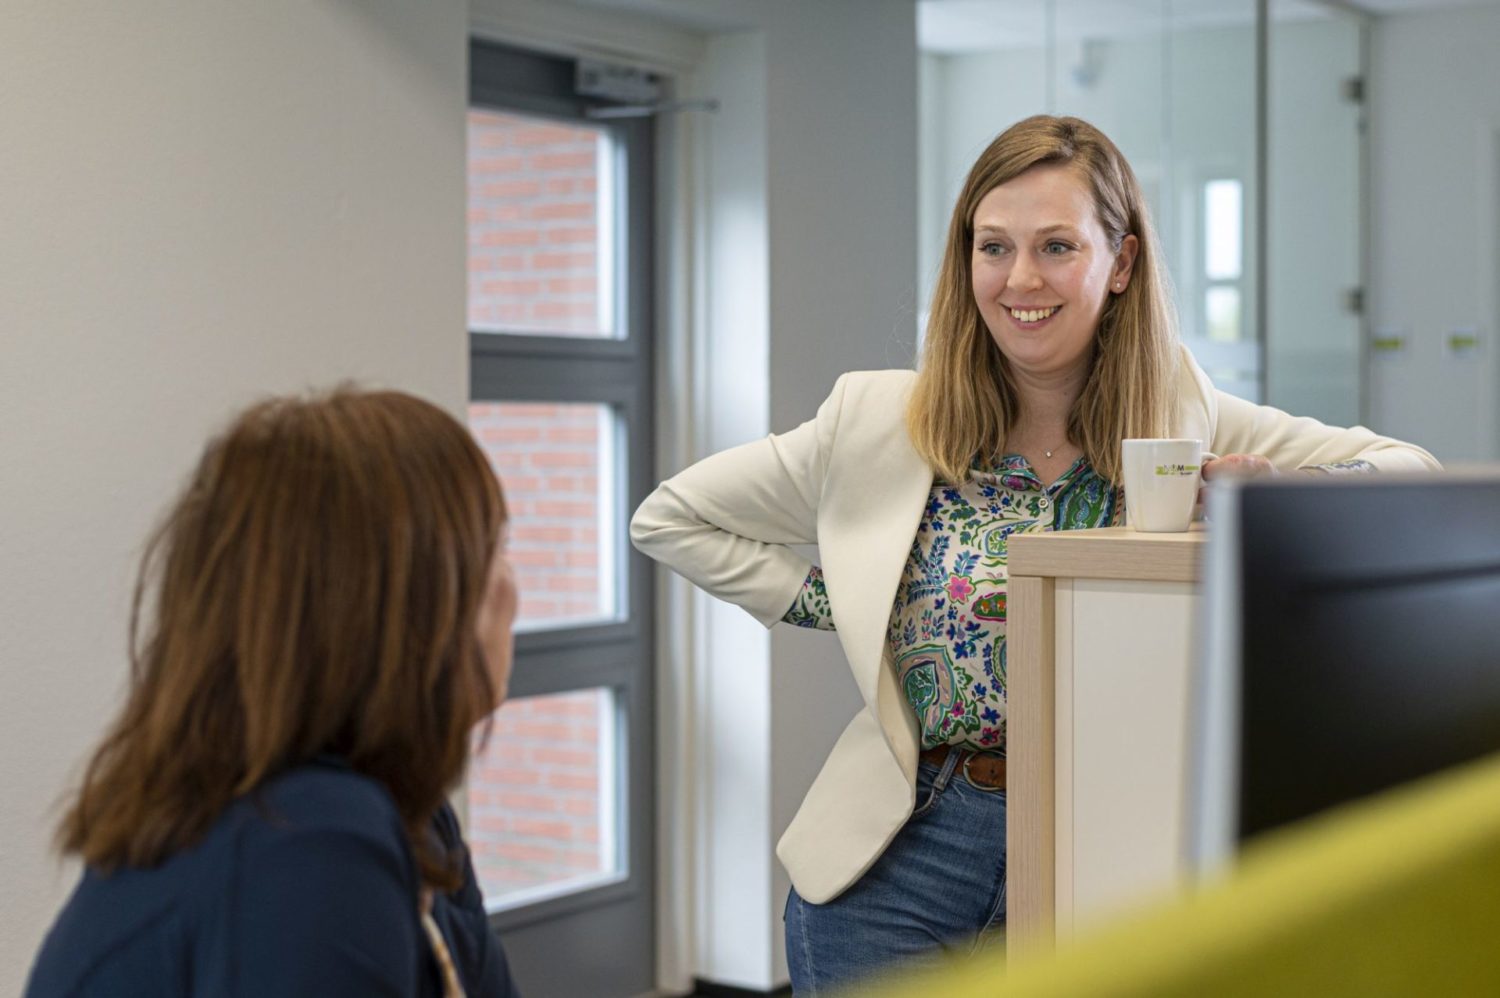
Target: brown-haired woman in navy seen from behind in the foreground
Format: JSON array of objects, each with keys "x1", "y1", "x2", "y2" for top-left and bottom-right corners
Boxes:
[{"x1": 27, "y1": 390, "x2": 516, "y2": 998}]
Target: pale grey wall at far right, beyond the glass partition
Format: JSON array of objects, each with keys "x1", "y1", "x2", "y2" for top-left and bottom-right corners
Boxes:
[{"x1": 1370, "y1": 5, "x2": 1500, "y2": 462}]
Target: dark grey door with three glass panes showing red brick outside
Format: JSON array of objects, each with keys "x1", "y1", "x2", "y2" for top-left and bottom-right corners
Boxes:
[{"x1": 467, "y1": 42, "x2": 656, "y2": 998}]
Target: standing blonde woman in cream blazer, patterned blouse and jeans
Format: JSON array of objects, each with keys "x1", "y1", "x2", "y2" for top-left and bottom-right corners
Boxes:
[{"x1": 632, "y1": 116, "x2": 1436, "y2": 996}]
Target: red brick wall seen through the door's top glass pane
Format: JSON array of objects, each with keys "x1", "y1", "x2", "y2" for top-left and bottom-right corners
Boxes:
[{"x1": 468, "y1": 110, "x2": 609, "y2": 336}]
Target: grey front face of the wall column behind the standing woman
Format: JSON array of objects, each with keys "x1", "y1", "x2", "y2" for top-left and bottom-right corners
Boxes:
[{"x1": 767, "y1": 0, "x2": 918, "y2": 981}]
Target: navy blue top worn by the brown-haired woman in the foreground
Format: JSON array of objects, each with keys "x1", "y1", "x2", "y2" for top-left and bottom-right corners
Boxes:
[{"x1": 26, "y1": 759, "x2": 516, "y2": 998}]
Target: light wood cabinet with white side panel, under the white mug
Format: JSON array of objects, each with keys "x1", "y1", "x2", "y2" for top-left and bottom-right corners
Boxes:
[{"x1": 1007, "y1": 524, "x2": 1205, "y2": 948}]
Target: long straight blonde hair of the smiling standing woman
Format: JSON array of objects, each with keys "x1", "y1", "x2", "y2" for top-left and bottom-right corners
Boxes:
[{"x1": 906, "y1": 114, "x2": 1178, "y2": 483}]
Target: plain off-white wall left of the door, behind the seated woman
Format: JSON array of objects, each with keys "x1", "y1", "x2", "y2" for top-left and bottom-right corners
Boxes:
[{"x1": 0, "y1": 0, "x2": 468, "y2": 993}]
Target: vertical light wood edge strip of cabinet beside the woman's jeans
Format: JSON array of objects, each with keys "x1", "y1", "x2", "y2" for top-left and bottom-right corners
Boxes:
[{"x1": 1005, "y1": 575, "x2": 1056, "y2": 953}]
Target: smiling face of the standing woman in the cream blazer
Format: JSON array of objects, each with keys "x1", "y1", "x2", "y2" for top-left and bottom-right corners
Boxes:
[{"x1": 969, "y1": 165, "x2": 1139, "y2": 375}]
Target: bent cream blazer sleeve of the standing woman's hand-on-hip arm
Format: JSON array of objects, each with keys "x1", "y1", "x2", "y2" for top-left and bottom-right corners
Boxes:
[{"x1": 630, "y1": 375, "x2": 848, "y2": 627}]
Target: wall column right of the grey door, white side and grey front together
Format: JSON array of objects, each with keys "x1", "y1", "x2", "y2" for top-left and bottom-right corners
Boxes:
[{"x1": 695, "y1": 0, "x2": 917, "y2": 989}]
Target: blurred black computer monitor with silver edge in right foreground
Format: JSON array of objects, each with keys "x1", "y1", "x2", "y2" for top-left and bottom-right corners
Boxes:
[{"x1": 1187, "y1": 473, "x2": 1500, "y2": 870}]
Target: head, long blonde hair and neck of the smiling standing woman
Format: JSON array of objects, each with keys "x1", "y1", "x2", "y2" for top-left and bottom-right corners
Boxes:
[{"x1": 911, "y1": 116, "x2": 1191, "y2": 482}]
